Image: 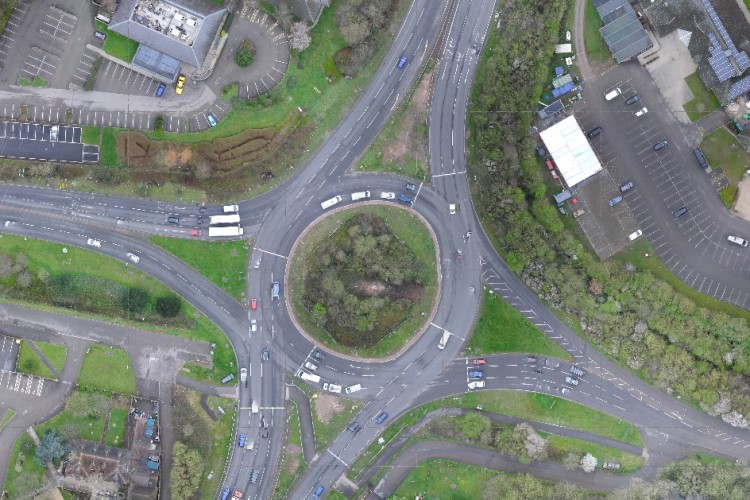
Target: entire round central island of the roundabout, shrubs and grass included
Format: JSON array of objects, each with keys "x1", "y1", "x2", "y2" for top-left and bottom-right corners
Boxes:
[{"x1": 287, "y1": 206, "x2": 437, "y2": 357}]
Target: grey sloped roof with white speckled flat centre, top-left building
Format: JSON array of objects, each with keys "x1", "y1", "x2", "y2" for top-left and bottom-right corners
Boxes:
[{"x1": 109, "y1": 0, "x2": 227, "y2": 68}]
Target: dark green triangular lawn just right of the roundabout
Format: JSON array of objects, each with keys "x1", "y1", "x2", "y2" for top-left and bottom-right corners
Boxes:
[{"x1": 466, "y1": 292, "x2": 571, "y2": 361}]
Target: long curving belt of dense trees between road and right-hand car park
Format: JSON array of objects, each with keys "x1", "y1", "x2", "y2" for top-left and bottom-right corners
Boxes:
[{"x1": 468, "y1": 0, "x2": 750, "y2": 426}]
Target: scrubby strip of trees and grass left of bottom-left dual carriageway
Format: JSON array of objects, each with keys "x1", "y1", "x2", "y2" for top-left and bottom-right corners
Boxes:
[{"x1": 171, "y1": 386, "x2": 235, "y2": 498}]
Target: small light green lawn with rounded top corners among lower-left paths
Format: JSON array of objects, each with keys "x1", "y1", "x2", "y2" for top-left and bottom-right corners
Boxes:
[{"x1": 76, "y1": 344, "x2": 135, "y2": 394}]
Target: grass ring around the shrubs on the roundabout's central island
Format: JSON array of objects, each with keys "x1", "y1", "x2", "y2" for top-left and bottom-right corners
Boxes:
[{"x1": 286, "y1": 205, "x2": 437, "y2": 357}]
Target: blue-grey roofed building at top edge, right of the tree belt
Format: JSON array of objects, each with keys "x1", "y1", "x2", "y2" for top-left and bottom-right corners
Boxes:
[{"x1": 593, "y1": 0, "x2": 653, "y2": 64}]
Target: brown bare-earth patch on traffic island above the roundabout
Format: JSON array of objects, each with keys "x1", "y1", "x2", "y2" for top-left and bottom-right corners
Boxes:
[{"x1": 383, "y1": 70, "x2": 435, "y2": 162}]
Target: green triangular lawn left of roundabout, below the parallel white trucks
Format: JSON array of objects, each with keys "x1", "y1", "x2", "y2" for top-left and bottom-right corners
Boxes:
[{"x1": 149, "y1": 236, "x2": 252, "y2": 302}]
